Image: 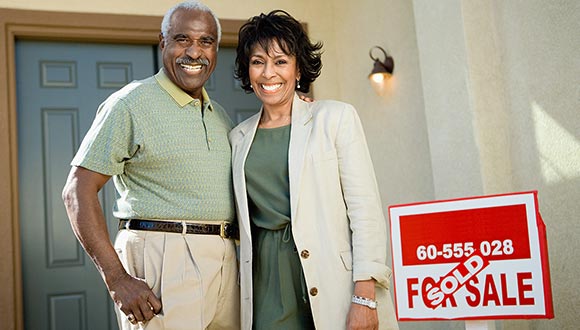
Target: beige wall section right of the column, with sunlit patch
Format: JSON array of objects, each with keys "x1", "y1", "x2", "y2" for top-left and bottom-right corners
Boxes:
[{"x1": 488, "y1": 0, "x2": 580, "y2": 329}]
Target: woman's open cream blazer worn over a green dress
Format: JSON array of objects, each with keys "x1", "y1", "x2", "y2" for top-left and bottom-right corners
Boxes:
[{"x1": 230, "y1": 95, "x2": 398, "y2": 330}]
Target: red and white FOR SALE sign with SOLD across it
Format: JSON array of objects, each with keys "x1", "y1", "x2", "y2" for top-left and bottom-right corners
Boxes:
[{"x1": 389, "y1": 191, "x2": 554, "y2": 320}]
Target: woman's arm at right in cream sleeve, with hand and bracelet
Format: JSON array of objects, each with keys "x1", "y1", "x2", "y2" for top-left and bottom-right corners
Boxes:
[{"x1": 336, "y1": 105, "x2": 389, "y2": 329}]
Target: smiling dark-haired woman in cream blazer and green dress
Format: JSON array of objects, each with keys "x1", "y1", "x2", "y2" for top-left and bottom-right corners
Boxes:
[{"x1": 230, "y1": 10, "x2": 397, "y2": 329}]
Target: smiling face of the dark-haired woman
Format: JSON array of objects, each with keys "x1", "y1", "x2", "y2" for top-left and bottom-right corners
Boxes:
[{"x1": 249, "y1": 41, "x2": 300, "y2": 109}]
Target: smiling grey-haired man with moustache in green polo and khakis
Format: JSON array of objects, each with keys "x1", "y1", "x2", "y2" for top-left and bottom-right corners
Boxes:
[{"x1": 63, "y1": 1, "x2": 239, "y2": 329}]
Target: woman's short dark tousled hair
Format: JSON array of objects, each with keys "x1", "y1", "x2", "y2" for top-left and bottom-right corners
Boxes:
[{"x1": 234, "y1": 10, "x2": 322, "y2": 93}]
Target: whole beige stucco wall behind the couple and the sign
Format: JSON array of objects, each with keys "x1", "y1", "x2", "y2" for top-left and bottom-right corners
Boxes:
[{"x1": 0, "y1": 0, "x2": 580, "y2": 329}]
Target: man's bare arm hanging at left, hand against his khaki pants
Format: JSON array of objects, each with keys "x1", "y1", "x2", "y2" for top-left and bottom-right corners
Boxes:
[{"x1": 62, "y1": 166, "x2": 161, "y2": 321}]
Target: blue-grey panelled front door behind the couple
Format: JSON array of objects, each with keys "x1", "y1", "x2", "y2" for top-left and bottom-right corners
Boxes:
[{"x1": 16, "y1": 41, "x2": 259, "y2": 330}]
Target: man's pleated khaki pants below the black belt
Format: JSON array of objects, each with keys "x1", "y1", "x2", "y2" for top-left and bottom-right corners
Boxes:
[{"x1": 115, "y1": 230, "x2": 240, "y2": 330}]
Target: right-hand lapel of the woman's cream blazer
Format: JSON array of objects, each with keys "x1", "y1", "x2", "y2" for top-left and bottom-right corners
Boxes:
[{"x1": 288, "y1": 94, "x2": 312, "y2": 221}]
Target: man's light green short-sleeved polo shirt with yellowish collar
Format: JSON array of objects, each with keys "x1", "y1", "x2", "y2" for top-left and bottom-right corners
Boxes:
[{"x1": 71, "y1": 69, "x2": 234, "y2": 221}]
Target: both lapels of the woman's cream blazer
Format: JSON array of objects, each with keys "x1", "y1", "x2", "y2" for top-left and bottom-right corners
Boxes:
[{"x1": 232, "y1": 94, "x2": 316, "y2": 222}]
